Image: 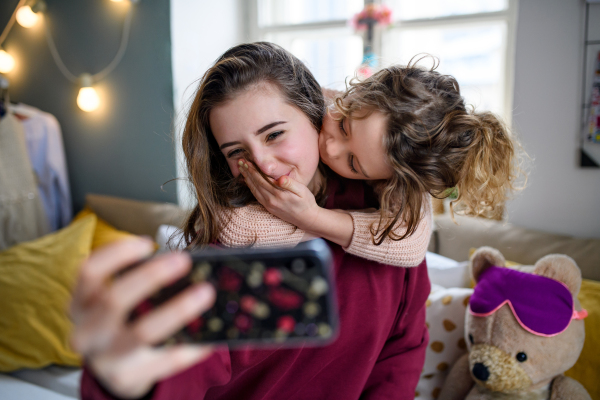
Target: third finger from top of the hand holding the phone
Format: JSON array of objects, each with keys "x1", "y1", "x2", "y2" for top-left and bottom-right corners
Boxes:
[{"x1": 130, "y1": 283, "x2": 216, "y2": 344}]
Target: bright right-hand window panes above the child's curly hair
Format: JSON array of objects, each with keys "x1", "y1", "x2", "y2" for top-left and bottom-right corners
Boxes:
[{"x1": 381, "y1": 0, "x2": 516, "y2": 122}]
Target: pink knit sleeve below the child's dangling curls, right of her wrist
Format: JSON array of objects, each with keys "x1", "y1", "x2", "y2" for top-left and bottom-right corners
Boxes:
[{"x1": 344, "y1": 199, "x2": 433, "y2": 267}]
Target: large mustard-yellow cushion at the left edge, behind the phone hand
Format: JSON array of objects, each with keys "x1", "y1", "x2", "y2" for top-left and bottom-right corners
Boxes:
[{"x1": 0, "y1": 216, "x2": 96, "y2": 372}]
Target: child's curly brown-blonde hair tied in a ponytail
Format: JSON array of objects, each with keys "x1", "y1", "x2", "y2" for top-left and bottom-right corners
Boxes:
[{"x1": 334, "y1": 58, "x2": 522, "y2": 244}]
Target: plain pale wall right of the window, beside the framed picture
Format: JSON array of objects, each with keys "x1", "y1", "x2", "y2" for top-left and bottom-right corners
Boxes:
[{"x1": 508, "y1": 0, "x2": 600, "y2": 237}]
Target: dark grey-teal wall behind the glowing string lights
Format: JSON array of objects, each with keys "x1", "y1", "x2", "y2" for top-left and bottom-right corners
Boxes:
[{"x1": 0, "y1": 0, "x2": 177, "y2": 211}]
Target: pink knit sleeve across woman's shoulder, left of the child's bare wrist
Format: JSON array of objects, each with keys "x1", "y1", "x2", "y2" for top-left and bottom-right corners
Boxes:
[{"x1": 219, "y1": 204, "x2": 304, "y2": 247}]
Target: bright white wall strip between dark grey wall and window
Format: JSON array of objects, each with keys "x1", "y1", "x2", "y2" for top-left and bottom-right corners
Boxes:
[{"x1": 171, "y1": 0, "x2": 243, "y2": 207}]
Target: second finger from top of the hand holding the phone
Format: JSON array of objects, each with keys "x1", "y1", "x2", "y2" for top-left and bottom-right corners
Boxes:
[{"x1": 110, "y1": 253, "x2": 192, "y2": 314}]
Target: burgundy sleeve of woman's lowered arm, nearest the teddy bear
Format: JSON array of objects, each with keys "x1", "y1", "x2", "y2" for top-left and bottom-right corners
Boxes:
[{"x1": 360, "y1": 261, "x2": 431, "y2": 400}]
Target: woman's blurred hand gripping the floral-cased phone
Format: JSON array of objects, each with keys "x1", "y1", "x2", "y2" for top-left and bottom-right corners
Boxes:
[{"x1": 71, "y1": 239, "x2": 215, "y2": 398}]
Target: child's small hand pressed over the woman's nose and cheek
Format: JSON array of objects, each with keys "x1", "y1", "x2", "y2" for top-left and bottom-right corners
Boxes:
[{"x1": 238, "y1": 160, "x2": 321, "y2": 231}]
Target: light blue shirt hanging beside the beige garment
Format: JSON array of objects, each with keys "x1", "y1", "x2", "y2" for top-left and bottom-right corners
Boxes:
[{"x1": 11, "y1": 104, "x2": 73, "y2": 231}]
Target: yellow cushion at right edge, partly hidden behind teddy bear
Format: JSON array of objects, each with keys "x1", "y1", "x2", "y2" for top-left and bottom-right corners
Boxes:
[{"x1": 565, "y1": 279, "x2": 600, "y2": 399}]
